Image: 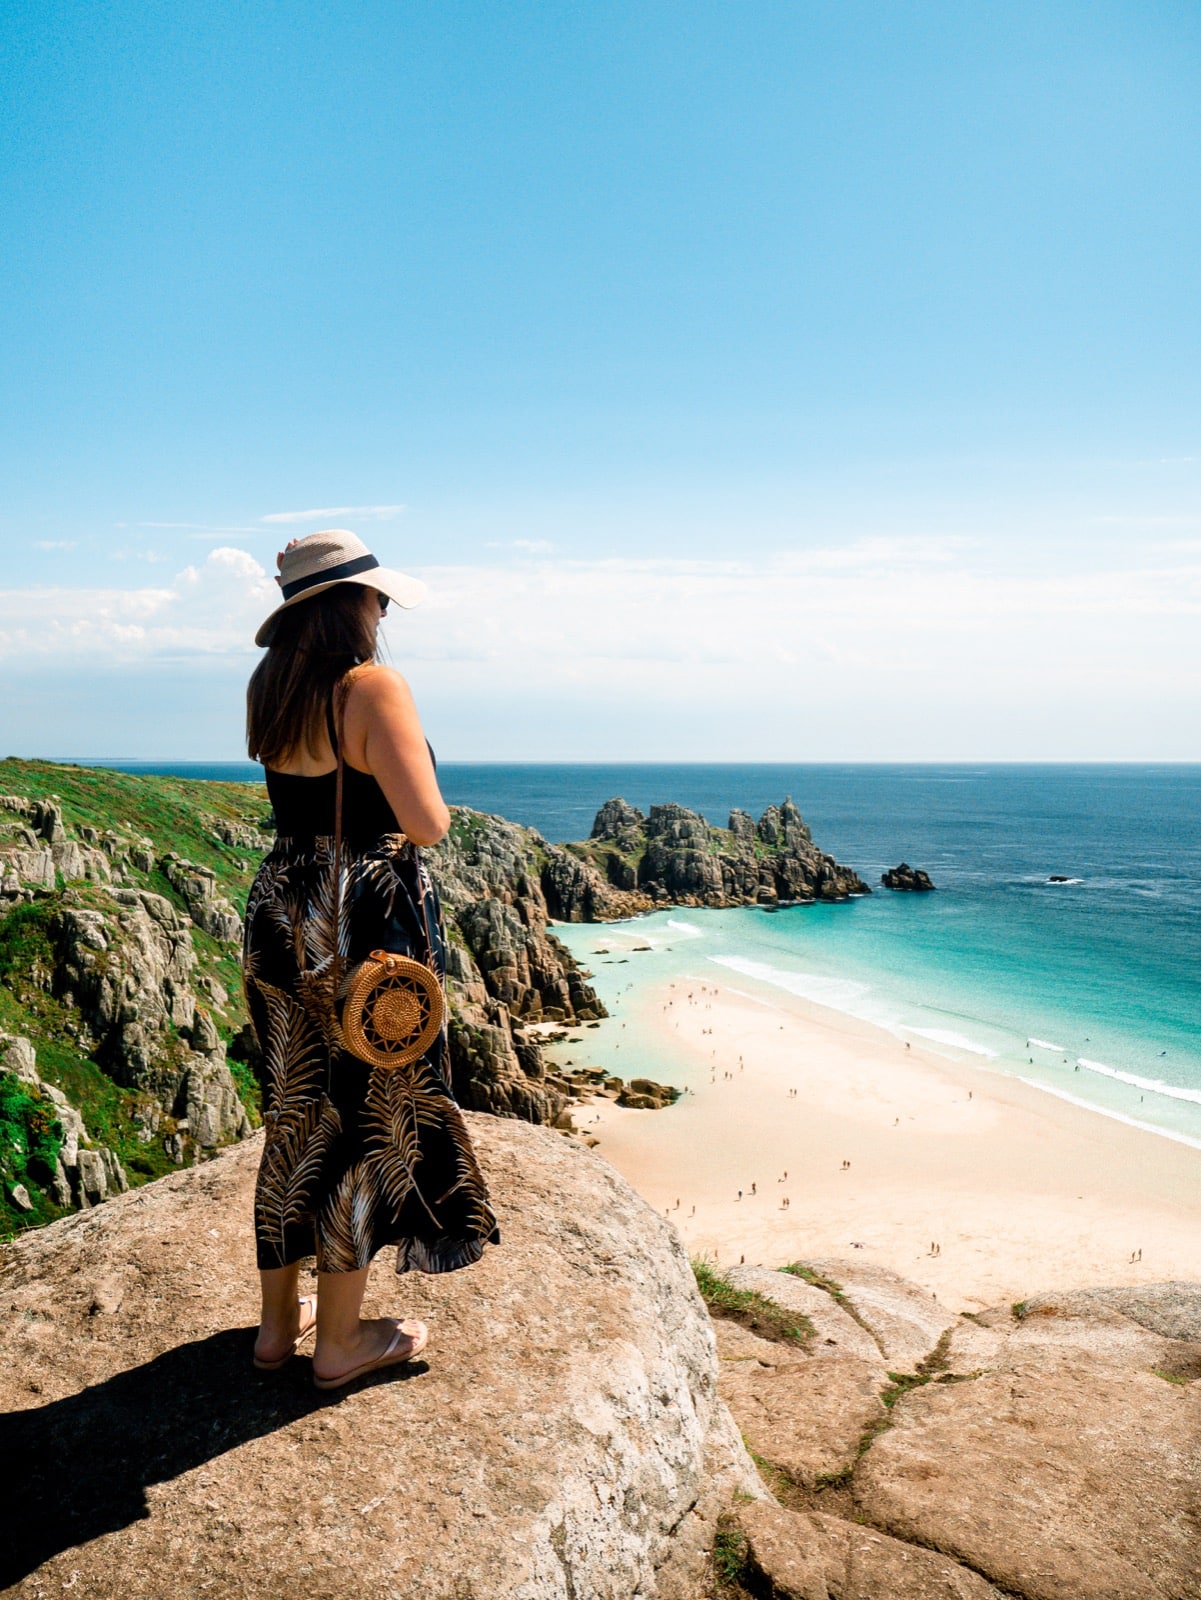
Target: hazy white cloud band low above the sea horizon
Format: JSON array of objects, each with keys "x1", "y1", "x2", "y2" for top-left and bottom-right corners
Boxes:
[{"x1": 0, "y1": 539, "x2": 1201, "y2": 760}]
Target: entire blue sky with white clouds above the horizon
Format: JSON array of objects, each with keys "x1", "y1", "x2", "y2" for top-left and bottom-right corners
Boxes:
[{"x1": 0, "y1": 0, "x2": 1201, "y2": 760}]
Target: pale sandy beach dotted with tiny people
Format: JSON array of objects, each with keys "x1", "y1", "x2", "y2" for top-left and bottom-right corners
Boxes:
[{"x1": 574, "y1": 982, "x2": 1201, "y2": 1310}]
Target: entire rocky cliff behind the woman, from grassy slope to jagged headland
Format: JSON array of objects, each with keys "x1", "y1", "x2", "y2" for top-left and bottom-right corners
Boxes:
[{"x1": 0, "y1": 760, "x2": 868, "y2": 1229}]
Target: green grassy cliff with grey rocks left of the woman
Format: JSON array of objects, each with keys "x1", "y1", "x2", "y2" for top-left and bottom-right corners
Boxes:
[{"x1": 0, "y1": 762, "x2": 267, "y2": 1227}]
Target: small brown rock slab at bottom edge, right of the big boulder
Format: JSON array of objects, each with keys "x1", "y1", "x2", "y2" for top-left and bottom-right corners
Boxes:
[{"x1": 737, "y1": 1501, "x2": 1000, "y2": 1600}]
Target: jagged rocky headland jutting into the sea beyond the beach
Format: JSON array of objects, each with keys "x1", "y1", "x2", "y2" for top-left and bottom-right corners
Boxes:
[{"x1": 544, "y1": 800, "x2": 870, "y2": 922}]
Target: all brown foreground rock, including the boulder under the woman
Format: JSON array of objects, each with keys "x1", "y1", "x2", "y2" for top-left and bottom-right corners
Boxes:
[{"x1": 0, "y1": 1114, "x2": 1201, "y2": 1600}]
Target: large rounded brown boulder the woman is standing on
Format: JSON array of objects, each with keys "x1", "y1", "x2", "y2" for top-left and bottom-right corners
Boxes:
[{"x1": 0, "y1": 1117, "x2": 763, "y2": 1600}]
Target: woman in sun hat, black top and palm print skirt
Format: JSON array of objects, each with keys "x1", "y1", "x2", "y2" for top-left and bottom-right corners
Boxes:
[{"x1": 243, "y1": 530, "x2": 499, "y2": 1389}]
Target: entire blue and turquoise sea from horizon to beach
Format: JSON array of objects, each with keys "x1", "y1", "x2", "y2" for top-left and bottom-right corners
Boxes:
[{"x1": 70, "y1": 762, "x2": 1201, "y2": 1149}]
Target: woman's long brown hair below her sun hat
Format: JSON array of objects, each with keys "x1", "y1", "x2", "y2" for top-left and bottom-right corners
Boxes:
[{"x1": 246, "y1": 584, "x2": 376, "y2": 766}]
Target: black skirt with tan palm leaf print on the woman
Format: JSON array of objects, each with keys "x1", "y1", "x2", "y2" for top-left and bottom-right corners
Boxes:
[{"x1": 243, "y1": 834, "x2": 499, "y2": 1272}]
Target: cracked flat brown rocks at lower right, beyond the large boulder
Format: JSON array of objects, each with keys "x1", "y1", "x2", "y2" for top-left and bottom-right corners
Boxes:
[{"x1": 720, "y1": 1261, "x2": 1201, "y2": 1600}]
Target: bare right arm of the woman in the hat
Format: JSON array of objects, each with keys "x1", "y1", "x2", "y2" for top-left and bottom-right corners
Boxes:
[{"x1": 345, "y1": 667, "x2": 451, "y2": 845}]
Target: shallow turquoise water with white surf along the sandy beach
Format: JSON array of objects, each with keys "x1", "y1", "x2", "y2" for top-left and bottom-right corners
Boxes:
[{"x1": 555, "y1": 896, "x2": 1201, "y2": 1149}]
